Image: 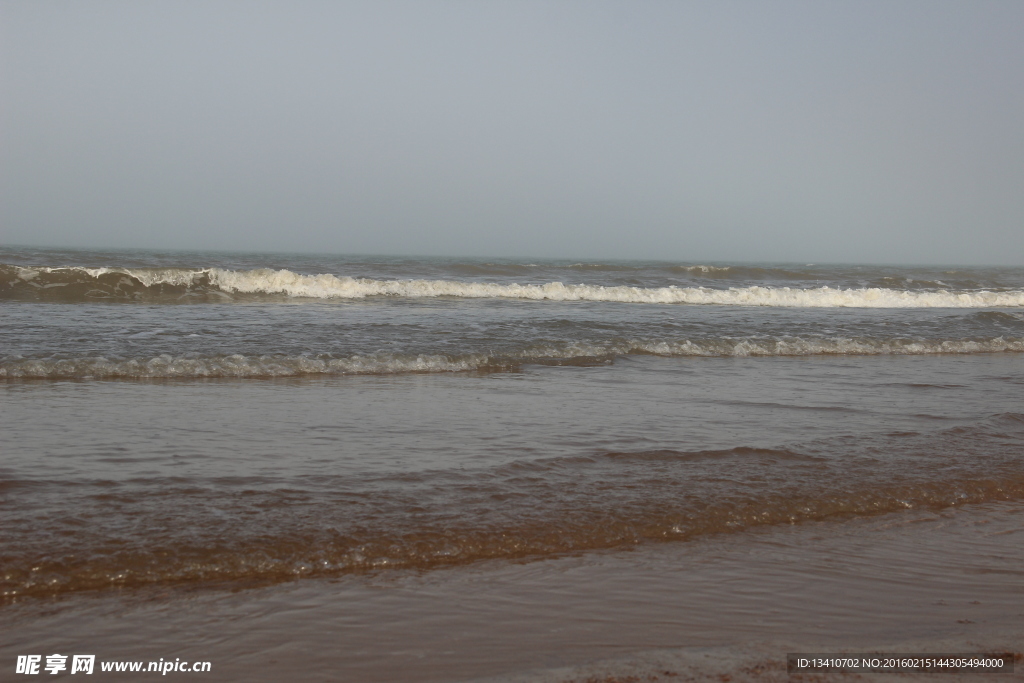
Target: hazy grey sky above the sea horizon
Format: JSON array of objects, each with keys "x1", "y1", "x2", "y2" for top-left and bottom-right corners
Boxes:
[{"x1": 0, "y1": 0, "x2": 1024, "y2": 264}]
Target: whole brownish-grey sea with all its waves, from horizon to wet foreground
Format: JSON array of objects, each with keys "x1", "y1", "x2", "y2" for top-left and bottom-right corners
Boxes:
[{"x1": 0, "y1": 248, "x2": 1024, "y2": 681}]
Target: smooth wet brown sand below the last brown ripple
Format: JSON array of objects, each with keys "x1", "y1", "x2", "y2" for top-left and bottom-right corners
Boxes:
[{"x1": 0, "y1": 502, "x2": 1024, "y2": 683}]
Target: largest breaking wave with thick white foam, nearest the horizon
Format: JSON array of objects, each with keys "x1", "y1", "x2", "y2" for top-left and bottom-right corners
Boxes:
[{"x1": 0, "y1": 266, "x2": 1024, "y2": 308}]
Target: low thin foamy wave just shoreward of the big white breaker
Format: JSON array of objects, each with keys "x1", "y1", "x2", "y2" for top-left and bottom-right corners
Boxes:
[{"x1": 0, "y1": 337, "x2": 1024, "y2": 380}]
